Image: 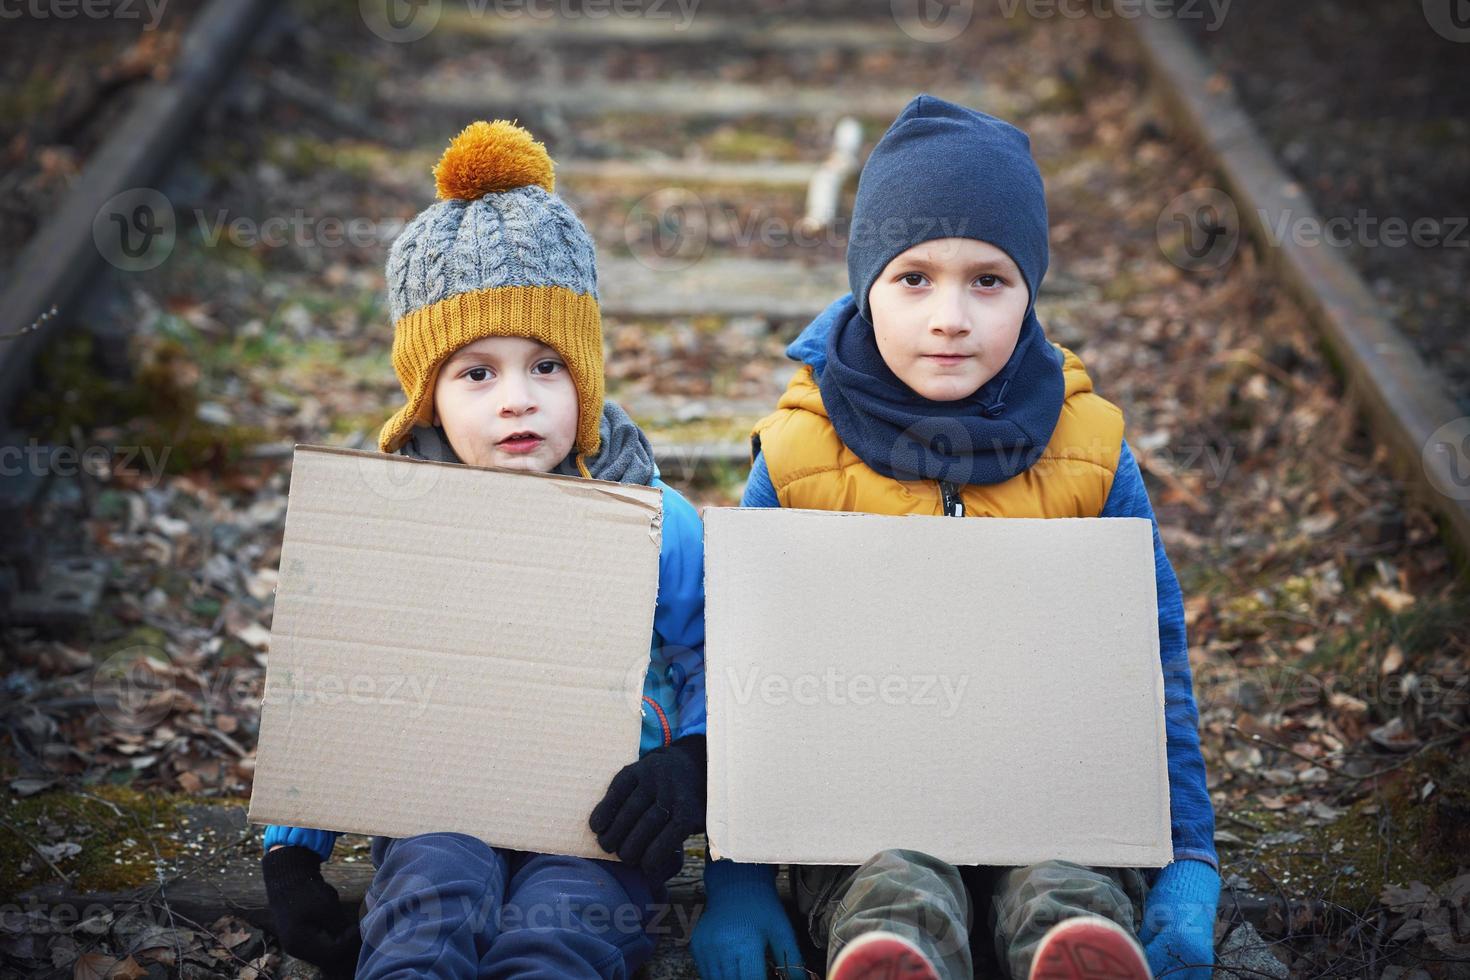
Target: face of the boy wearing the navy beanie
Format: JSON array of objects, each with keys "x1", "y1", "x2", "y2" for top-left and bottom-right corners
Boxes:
[{"x1": 867, "y1": 238, "x2": 1030, "y2": 401}]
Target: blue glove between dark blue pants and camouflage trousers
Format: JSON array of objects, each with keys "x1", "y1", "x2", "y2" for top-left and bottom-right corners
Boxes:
[{"x1": 689, "y1": 861, "x2": 807, "y2": 980}]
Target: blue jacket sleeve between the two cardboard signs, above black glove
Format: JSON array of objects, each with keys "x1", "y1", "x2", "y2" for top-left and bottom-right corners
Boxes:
[{"x1": 653, "y1": 480, "x2": 704, "y2": 739}]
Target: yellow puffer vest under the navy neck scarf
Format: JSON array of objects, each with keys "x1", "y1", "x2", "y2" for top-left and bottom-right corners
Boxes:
[{"x1": 751, "y1": 344, "x2": 1123, "y2": 517}]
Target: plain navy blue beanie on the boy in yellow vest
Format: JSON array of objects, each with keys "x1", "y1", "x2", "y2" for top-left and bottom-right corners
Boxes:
[{"x1": 847, "y1": 96, "x2": 1047, "y2": 323}]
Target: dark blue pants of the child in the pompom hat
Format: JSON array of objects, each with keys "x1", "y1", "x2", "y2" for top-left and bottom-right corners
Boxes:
[{"x1": 357, "y1": 833, "x2": 667, "y2": 980}]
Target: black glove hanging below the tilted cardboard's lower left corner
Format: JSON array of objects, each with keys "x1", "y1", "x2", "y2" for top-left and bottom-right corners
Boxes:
[{"x1": 260, "y1": 845, "x2": 363, "y2": 979}]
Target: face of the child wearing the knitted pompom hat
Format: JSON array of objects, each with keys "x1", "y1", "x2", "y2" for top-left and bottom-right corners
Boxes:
[{"x1": 434, "y1": 336, "x2": 578, "y2": 473}]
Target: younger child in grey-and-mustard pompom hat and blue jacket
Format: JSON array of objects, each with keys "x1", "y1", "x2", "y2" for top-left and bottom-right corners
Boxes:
[{"x1": 262, "y1": 120, "x2": 706, "y2": 977}]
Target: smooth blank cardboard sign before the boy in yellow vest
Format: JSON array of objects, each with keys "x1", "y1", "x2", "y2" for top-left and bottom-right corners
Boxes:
[{"x1": 704, "y1": 508, "x2": 1172, "y2": 867}]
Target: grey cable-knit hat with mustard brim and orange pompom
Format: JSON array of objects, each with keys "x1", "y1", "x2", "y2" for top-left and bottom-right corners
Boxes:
[{"x1": 378, "y1": 119, "x2": 603, "y2": 476}]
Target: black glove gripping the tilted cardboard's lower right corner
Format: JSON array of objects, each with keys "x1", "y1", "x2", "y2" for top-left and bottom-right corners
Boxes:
[{"x1": 587, "y1": 735, "x2": 704, "y2": 882}]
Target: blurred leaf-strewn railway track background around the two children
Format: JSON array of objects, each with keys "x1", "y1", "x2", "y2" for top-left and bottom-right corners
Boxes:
[{"x1": 0, "y1": 0, "x2": 1470, "y2": 980}]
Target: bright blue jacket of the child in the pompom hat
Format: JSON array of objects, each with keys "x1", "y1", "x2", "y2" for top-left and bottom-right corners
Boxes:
[{"x1": 265, "y1": 475, "x2": 704, "y2": 861}]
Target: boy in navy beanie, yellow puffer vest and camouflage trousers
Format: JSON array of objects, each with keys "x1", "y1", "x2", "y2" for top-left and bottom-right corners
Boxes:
[{"x1": 692, "y1": 96, "x2": 1220, "y2": 980}]
